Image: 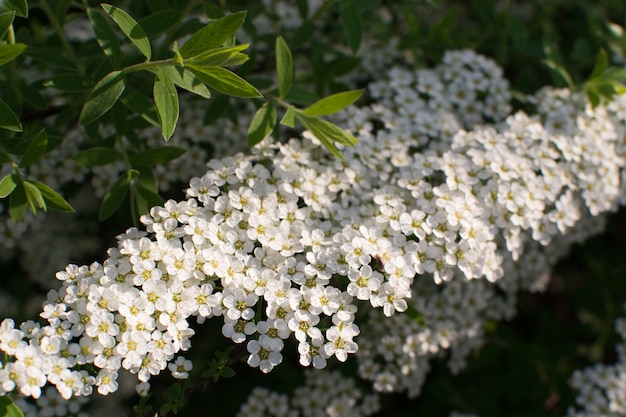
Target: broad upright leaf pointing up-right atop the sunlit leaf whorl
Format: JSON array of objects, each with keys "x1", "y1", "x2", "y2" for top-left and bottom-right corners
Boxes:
[{"x1": 180, "y1": 12, "x2": 246, "y2": 59}]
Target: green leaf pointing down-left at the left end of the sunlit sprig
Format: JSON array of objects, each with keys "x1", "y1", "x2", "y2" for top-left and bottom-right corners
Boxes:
[{"x1": 79, "y1": 71, "x2": 126, "y2": 125}]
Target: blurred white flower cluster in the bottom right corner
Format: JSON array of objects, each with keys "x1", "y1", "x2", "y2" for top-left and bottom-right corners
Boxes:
[{"x1": 567, "y1": 306, "x2": 626, "y2": 417}]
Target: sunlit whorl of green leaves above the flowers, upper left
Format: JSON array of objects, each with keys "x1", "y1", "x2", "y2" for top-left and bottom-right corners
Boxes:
[{"x1": 80, "y1": 4, "x2": 261, "y2": 140}]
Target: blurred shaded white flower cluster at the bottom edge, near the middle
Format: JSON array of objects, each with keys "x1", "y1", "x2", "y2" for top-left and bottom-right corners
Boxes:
[{"x1": 237, "y1": 371, "x2": 380, "y2": 417}]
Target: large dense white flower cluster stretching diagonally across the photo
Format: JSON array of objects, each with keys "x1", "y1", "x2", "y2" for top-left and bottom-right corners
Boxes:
[{"x1": 0, "y1": 51, "x2": 626, "y2": 410}]
